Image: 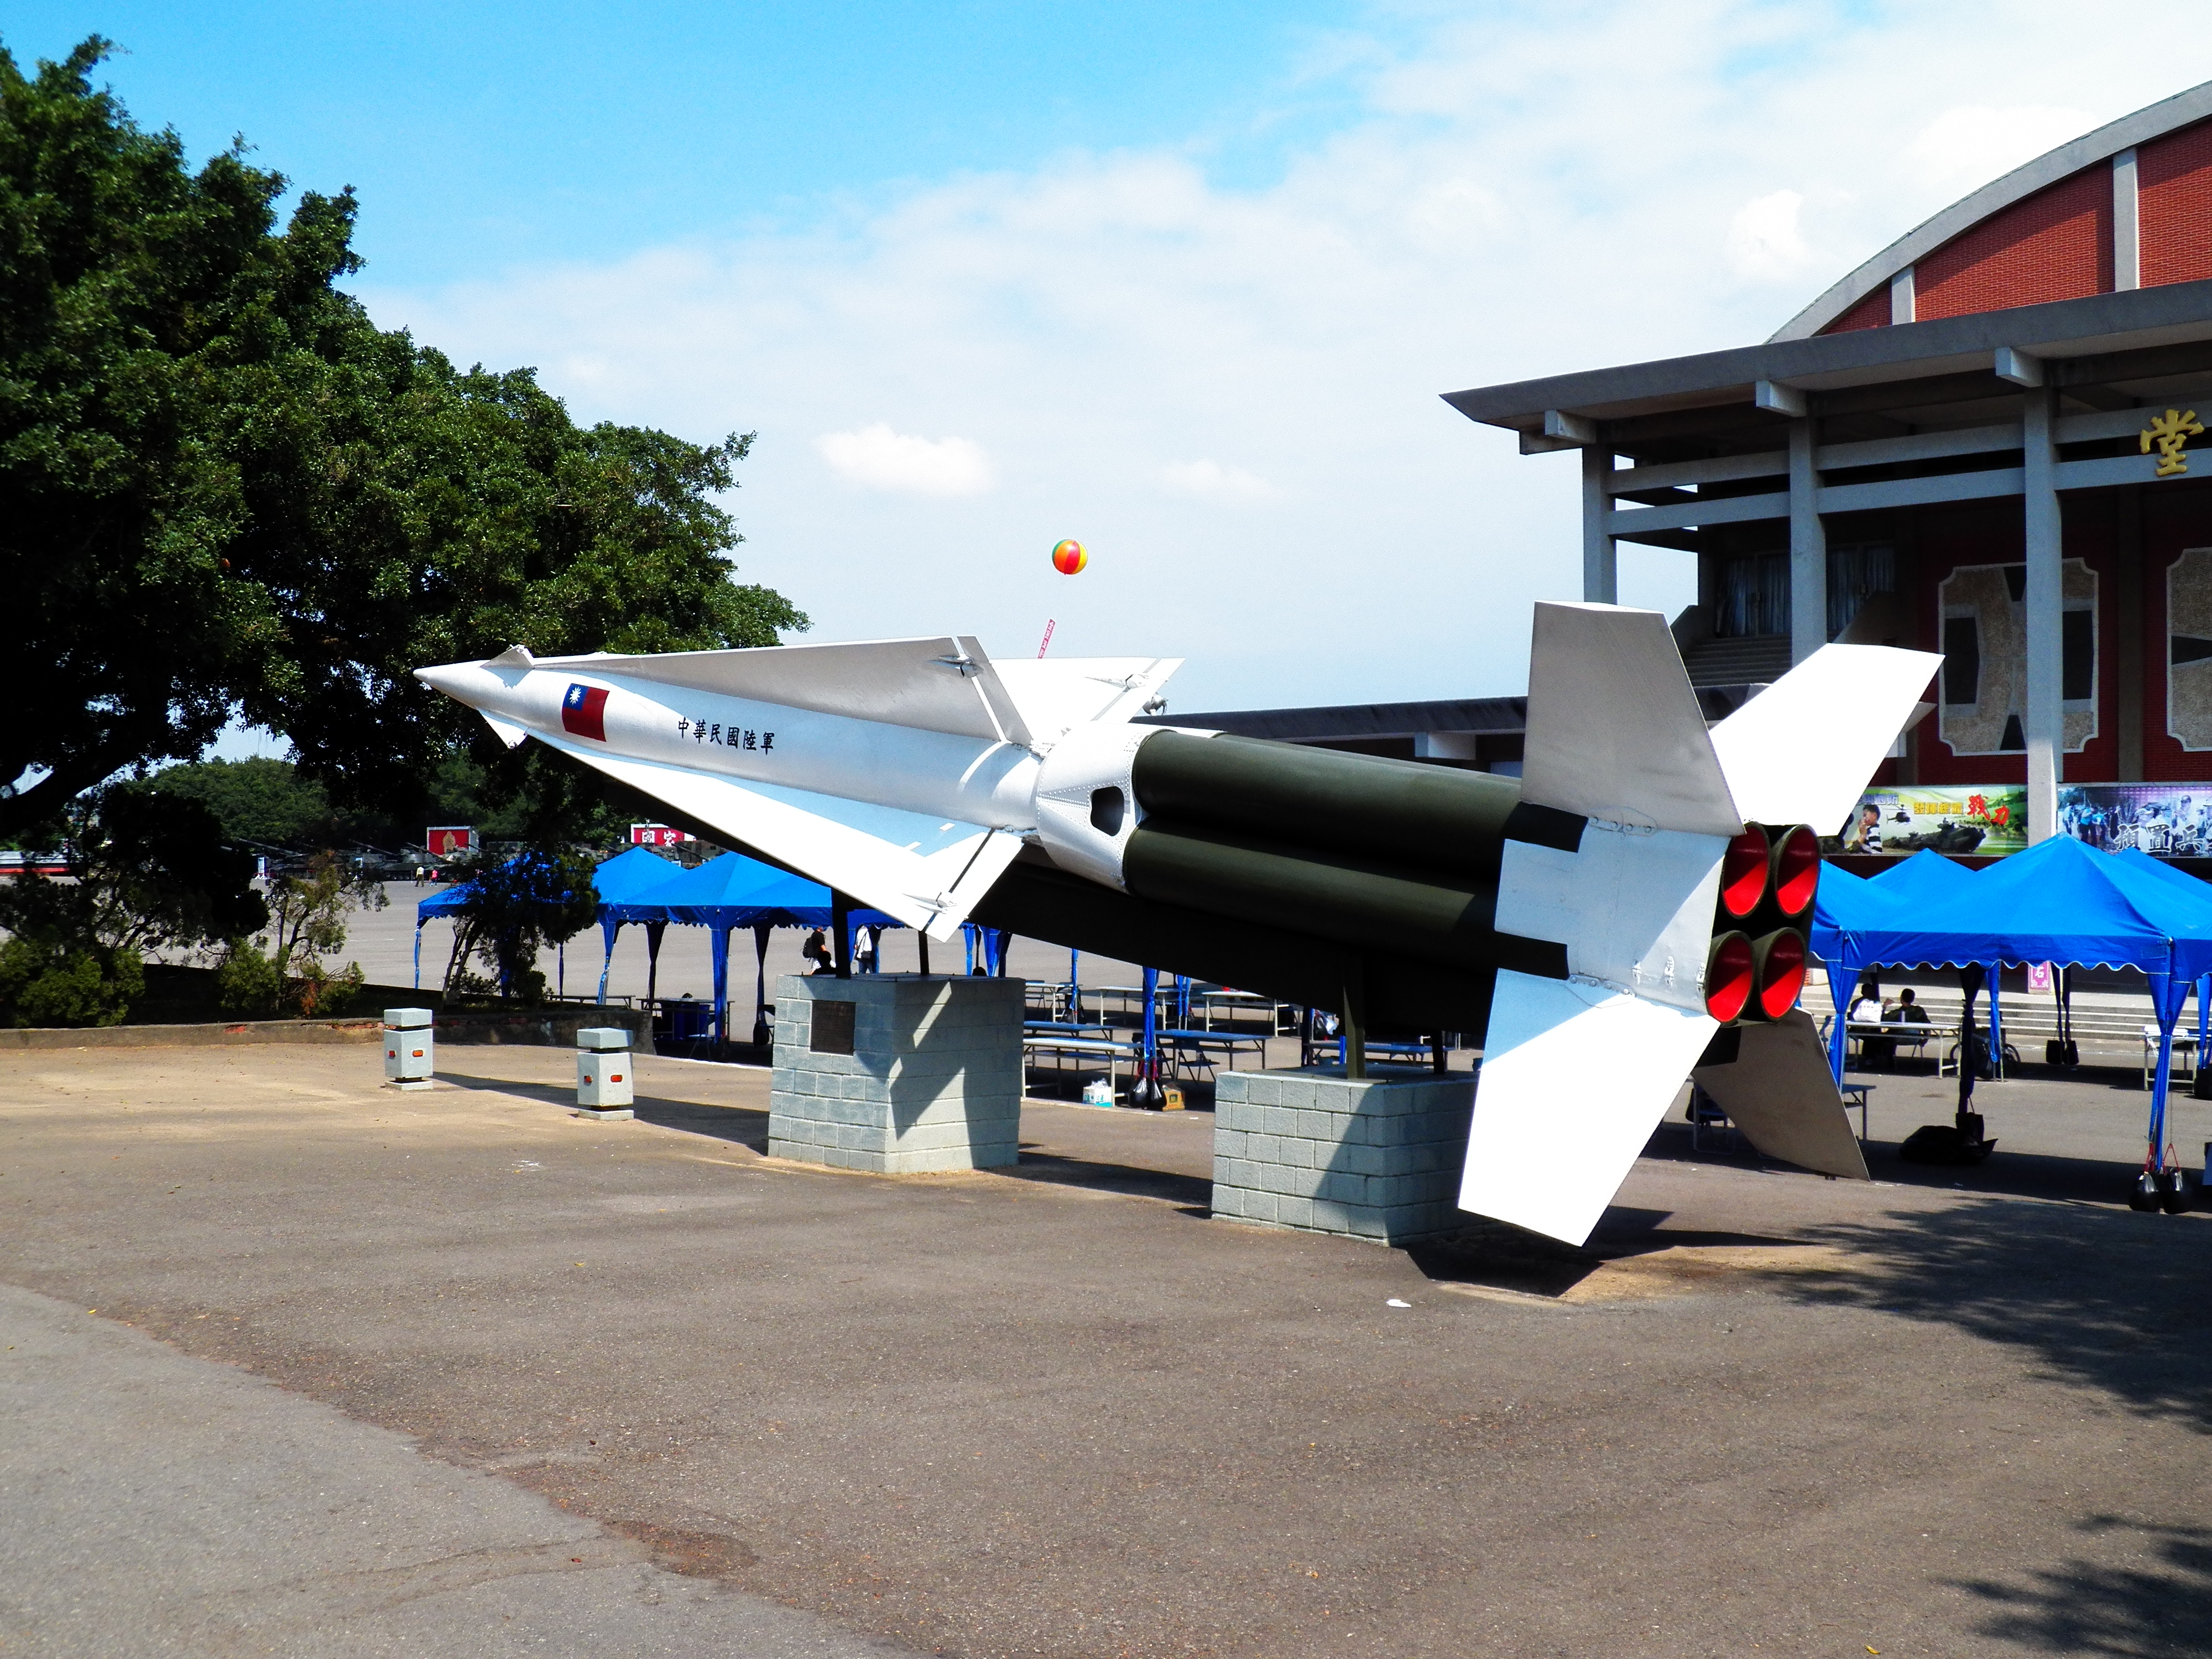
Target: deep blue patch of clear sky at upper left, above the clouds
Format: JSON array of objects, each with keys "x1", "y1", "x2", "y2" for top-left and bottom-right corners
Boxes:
[{"x1": 0, "y1": 0, "x2": 1378, "y2": 285}]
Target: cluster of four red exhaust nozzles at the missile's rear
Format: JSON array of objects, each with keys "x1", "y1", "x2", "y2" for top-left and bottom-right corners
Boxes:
[{"x1": 1705, "y1": 823, "x2": 1820, "y2": 1024}]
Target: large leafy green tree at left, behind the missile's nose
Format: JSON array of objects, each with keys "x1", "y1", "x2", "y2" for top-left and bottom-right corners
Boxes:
[{"x1": 0, "y1": 38, "x2": 805, "y2": 838}]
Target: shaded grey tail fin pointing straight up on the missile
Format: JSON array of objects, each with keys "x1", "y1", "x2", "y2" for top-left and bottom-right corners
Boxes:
[{"x1": 1522, "y1": 604, "x2": 1743, "y2": 836}]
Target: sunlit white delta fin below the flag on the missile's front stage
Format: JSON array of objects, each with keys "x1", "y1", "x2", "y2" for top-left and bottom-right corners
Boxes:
[{"x1": 557, "y1": 732, "x2": 1022, "y2": 942}]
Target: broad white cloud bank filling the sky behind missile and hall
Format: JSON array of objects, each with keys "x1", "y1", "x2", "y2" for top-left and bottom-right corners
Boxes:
[{"x1": 367, "y1": 0, "x2": 2212, "y2": 710}]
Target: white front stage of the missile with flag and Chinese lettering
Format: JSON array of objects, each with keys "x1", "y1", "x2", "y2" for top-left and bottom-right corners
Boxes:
[{"x1": 416, "y1": 635, "x2": 1181, "y2": 940}]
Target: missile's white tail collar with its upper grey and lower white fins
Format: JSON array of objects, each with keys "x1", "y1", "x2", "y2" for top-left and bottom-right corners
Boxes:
[{"x1": 1460, "y1": 604, "x2": 1743, "y2": 1245}]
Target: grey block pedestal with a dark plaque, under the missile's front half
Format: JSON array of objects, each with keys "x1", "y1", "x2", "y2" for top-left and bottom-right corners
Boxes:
[{"x1": 768, "y1": 973, "x2": 1024, "y2": 1175}]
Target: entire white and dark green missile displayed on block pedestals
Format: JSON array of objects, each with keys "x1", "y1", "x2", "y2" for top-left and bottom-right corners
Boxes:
[{"x1": 416, "y1": 604, "x2": 1940, "y2": 1243}]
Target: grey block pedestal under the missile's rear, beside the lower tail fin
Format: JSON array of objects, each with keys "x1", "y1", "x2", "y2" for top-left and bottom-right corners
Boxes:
[{"x1": 1214, "y1": 1066, "x2": 1475, "y2": 1245}]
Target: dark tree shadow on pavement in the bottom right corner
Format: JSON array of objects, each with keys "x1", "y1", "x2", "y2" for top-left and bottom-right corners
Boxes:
[{"x1": 1953, "y1": 1515, "x2": 2212, "y2": 1659}]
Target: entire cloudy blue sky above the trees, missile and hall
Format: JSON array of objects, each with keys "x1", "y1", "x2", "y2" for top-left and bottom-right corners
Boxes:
[{"x1": 17, "y1": 0, "x2": 2212, "y2": 748}]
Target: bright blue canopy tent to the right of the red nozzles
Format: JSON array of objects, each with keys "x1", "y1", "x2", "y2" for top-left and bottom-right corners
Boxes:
[{"x1": 1814, "y1": 836, "x2": 2212, "y2": 1168}]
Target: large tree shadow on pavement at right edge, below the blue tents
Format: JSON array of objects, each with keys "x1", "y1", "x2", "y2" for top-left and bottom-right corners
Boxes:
[{"x1": 1776, "y1": 1199, "x2": 2212, "y2": 1433}]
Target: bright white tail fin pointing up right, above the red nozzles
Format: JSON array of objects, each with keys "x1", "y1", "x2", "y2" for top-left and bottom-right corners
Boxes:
[{"x1": 1712, "y1": 646, "x2": 1942, "y2": 836}]
